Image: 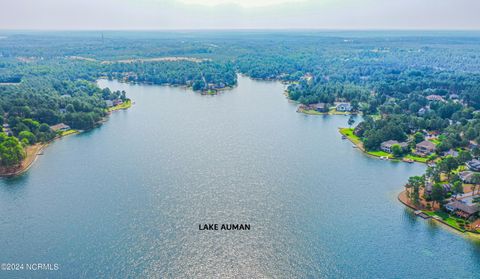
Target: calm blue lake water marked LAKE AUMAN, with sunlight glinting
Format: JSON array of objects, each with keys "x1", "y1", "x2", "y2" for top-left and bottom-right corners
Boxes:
[{"x1": 0, "y1": 77, "x2": 480, "y2": 278}]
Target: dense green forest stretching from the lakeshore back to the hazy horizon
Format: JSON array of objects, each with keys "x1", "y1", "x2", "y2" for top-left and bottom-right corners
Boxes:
[{"x1": 0, "y1": 31, "x2": 480, "y2": 166}]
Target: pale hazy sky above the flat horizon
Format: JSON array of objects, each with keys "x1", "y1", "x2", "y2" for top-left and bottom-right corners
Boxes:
[{"x1": 0, "y1": 0, "x2": 480, "y2": 30}]
